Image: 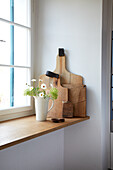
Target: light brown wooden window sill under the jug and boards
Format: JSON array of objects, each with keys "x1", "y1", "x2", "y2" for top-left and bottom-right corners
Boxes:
[{"x1": 0, "y1": 116, "x2": 90, "y2": 150}]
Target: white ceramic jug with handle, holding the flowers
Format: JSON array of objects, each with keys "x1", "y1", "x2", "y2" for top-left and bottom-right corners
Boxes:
[{"x1": 34, "y1": 96, "x2": 54, "y2": 122}]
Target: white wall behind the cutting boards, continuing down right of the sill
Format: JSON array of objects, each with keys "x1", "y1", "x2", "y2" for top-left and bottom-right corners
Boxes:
[{"x1": 35, "y1": 0, "x2": 102, "y2": 170}]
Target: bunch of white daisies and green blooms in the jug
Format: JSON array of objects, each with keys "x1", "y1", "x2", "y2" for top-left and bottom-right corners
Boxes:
[{"x1": 24, "y1": 79, "x2": 58, "y2": 100}]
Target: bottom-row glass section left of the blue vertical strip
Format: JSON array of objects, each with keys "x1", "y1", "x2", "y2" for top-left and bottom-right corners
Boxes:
[{"x1": 0, "y1": 67, "x2": 10, "y2": 109}]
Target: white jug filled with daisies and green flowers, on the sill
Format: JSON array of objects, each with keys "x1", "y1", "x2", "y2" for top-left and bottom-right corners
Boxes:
[{"x1": 24, "y1": 79, "x2": 58, "y2": 121}]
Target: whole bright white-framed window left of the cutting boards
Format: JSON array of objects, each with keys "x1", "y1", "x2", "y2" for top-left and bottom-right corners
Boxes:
[{"x1": 0, "y1": 0, "x2": 32, "y2": 120}]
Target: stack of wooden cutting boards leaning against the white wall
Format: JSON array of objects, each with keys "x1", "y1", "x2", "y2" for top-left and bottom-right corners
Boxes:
[{"x1": 40, "y1": 52, "x2": 86, "y2": 118}]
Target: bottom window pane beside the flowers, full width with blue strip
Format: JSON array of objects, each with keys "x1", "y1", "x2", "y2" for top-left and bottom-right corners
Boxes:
[{"x1": 0, "y1": 67, "x2": 31, "y2": 109}]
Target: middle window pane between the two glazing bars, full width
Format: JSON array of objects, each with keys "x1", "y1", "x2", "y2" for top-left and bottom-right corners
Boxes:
[{"x1": 0, "y1": 21, "x2": 30, "y2": 66}]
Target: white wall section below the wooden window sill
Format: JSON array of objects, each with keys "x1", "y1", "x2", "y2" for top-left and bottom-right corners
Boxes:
[{"x1": 0, "y1": 129, "x2": 64, "y2": 170}]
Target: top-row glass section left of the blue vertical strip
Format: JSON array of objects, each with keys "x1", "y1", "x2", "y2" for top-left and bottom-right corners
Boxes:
[{"x1": 0, "y1": 0, "x2": 10, "y2": 20}]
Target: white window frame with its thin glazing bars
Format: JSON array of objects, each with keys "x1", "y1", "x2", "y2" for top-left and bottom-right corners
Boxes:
[{"x1": 0, "y1": 0, "x2": 34, "y2": 122}]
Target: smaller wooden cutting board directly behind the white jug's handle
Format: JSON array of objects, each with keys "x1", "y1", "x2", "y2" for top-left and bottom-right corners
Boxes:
[{"x1": 48, "y1": 78, "x2": 68, "y2": 118}]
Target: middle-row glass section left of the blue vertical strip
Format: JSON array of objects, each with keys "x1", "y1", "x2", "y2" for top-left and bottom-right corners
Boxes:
[{"x1": 0, "y1": 21, "x2": 10, "y2": 64}]
